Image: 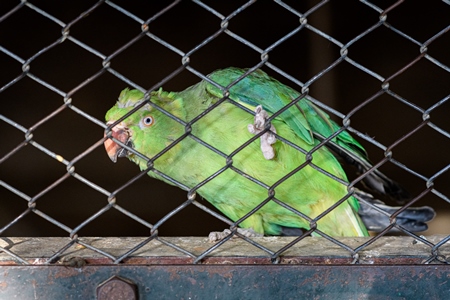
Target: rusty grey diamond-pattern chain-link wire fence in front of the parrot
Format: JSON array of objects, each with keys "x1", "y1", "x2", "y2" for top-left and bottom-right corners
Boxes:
[{"x1": 0, "y1": 0, "x2": 450, "y2": 264}]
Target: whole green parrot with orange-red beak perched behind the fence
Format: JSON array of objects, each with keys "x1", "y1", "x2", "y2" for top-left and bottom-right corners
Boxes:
[{"x1": 105, "y1": 68, "x2": 434, "y2": 240}]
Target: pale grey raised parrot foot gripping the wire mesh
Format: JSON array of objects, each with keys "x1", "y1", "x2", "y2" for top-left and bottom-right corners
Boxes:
[{"x1": 248, "y1": 105, "x2": 277, "y2": 159}]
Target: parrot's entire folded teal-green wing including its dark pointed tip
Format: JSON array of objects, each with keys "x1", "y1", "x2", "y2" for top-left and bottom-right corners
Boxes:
[{"x1": 206, "y1": 68, "x2": 409, "y2": 202}]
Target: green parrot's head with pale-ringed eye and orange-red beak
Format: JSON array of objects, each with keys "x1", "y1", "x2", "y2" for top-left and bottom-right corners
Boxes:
[{"x1": 104, "y1": 89, "x2": 185, "y2": 169}]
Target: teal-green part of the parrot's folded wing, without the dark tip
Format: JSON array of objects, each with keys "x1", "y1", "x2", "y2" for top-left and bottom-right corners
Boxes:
[{"x1": 207, "y1": 68, "x2": 367, "y2": 151}]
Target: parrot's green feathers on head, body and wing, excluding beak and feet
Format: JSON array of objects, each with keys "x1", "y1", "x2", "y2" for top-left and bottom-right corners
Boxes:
[{"x1": 106, "y1": 68, "x2": 368, "y2": 236}]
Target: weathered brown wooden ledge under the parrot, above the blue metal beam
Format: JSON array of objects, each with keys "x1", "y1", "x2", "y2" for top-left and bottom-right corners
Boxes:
[{"x1": 0, "y1": 235, "x2": 450, "y2": 265}]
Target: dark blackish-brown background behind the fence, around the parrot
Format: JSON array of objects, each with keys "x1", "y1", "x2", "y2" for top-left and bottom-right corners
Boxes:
[{"x1": 0, "y1": 0, "x2": 450, "y2": 236}]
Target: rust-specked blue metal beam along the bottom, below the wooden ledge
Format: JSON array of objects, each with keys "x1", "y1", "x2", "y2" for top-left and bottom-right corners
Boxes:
[{"x1": 0, "y1": 265, "x2": 450, "y2": 299}]
